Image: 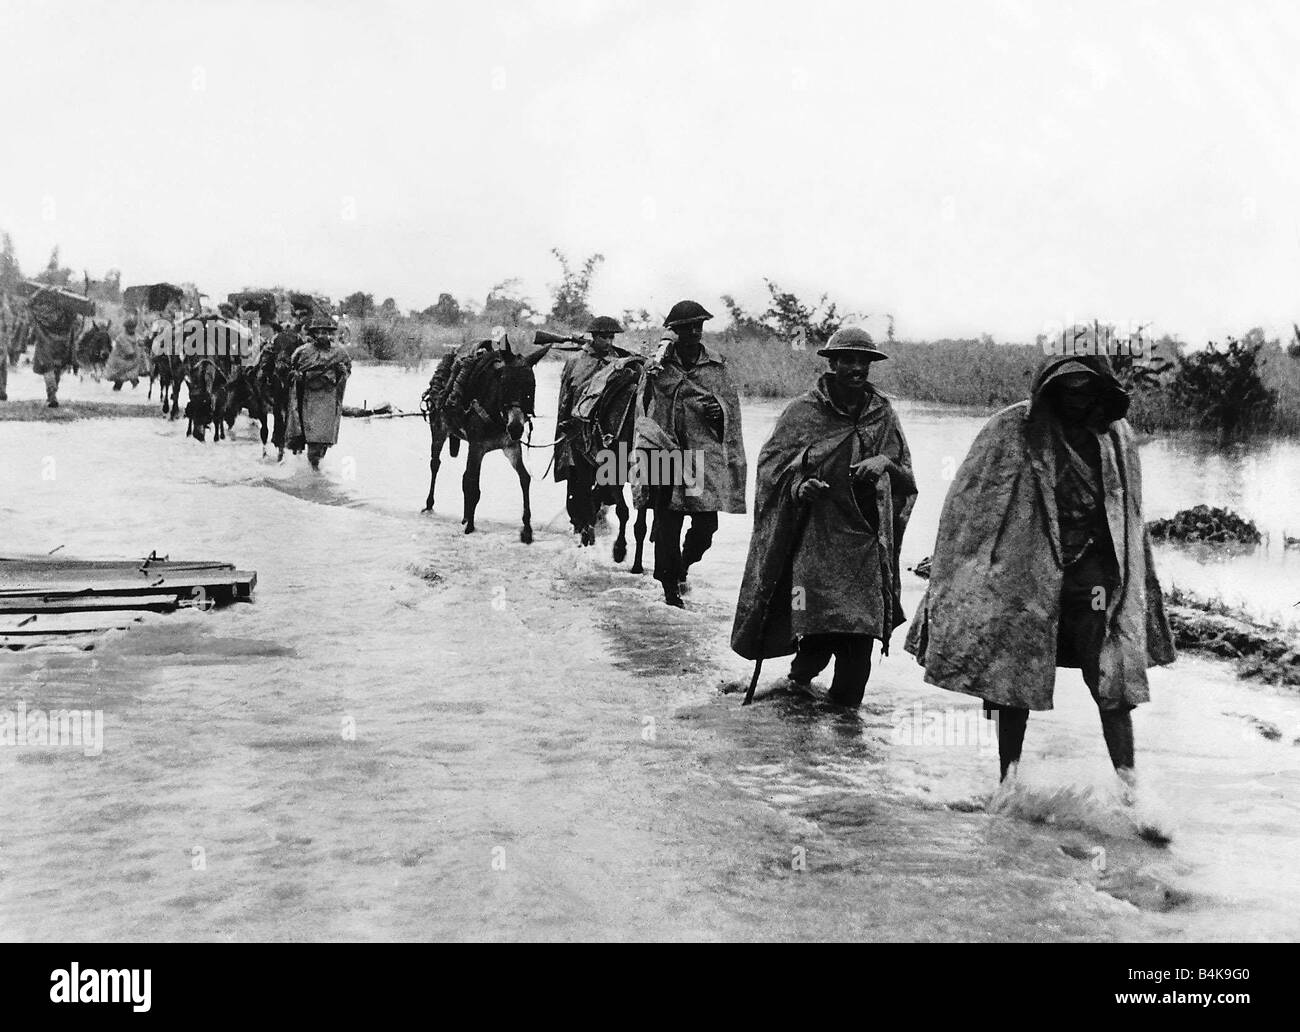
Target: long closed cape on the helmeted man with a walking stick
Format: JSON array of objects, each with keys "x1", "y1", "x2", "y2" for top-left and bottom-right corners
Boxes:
[{"x1": 732, "y1": 377, "x2": 917, "y2": 659}]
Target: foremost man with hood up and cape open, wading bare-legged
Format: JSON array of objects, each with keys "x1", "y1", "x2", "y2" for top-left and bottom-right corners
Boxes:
[{"x1": 907, "y1": 356, "x2": 1175, "y2": 786}]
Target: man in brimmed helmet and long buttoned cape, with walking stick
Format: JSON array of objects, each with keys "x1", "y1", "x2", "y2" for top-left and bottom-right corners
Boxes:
[{"x1": 732, "y1": 328, "x2": 917, "y2": 707}]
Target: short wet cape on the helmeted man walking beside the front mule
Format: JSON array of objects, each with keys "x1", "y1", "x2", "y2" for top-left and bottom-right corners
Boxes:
[{"x1": 632, "y1": 344, "x2": 746, "y2": 513}]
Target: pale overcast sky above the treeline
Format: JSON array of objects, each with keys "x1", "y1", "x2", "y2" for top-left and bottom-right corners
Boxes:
[{"x1": 0, "y1": 0, "x2": 1300, "y2": 341}]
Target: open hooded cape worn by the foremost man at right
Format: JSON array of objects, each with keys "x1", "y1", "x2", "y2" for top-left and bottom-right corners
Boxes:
[{"x1": 906, "y1": 356, "x2": 1175, "y2": 710}]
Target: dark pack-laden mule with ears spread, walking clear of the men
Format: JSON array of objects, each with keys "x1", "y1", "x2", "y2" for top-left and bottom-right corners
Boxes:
[{"x1": 424, "y1": 343, "x2": 551, "y2": 545}]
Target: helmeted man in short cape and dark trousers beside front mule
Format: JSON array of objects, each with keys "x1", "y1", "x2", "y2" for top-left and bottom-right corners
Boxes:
[{"x1": 633, "y1": 302, "x2": 745, "y2": 608}]
